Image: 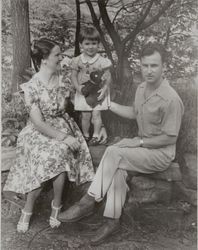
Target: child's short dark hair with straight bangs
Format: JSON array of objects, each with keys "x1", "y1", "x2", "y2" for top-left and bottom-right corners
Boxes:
[{"x1": 79, "y1": 26, "x2": 100, "y2": 43}]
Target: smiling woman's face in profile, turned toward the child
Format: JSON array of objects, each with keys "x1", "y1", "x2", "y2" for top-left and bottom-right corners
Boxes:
[{"x1": 45, "y1": 45, "x2": 62, "y2": 72}]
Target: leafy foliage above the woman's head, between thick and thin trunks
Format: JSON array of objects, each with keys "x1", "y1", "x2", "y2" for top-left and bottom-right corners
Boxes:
[{"x1": 29, "y1": 0, "x2": 75, "y2": 47}]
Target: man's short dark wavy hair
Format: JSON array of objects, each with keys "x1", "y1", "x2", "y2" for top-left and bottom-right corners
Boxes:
[{"x1": 140, "y1": 42, "x2": 166, "y2": 63}]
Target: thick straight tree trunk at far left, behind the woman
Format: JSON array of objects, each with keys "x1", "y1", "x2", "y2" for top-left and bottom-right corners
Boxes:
[{"x1": 11, "y1": 0, "x2": 31, "y2": 92}]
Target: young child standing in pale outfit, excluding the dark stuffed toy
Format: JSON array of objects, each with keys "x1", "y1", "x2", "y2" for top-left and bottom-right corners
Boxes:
[{"x1": 71, "y1": 26, "x2": 112, "y2": 145}]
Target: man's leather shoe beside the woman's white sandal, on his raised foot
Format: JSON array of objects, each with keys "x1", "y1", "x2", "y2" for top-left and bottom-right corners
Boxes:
[{"x1": 58, "y1": 199, "x2": 94, "y2": 222}]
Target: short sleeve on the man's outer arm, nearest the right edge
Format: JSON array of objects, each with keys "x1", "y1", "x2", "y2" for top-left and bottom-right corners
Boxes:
[{"x1": 161, "y1": 98, "x2": 184, "y2": 136}]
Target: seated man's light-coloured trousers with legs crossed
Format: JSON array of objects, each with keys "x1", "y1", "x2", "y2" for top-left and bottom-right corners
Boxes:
[{"x1": 88, "y1": 144, "x2": 172, "y2": 219}]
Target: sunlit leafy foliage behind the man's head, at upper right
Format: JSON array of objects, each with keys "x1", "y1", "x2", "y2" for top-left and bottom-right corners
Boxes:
[{"x1": 87, "y1": 0, "x2": 198, "y2": 79}]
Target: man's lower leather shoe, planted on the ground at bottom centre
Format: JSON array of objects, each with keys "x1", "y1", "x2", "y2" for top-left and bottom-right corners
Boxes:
[{"x1": 91, "y1": 219, "x2": 120, "y2": 246}]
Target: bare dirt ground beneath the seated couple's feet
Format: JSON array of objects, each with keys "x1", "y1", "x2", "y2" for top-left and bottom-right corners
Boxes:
[{"x1": 1, "y1": 173, "x2": 197, "y2": 250}]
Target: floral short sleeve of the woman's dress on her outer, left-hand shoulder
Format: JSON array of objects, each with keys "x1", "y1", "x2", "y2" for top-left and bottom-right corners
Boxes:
[{"x1": 20, "y1": 81, "x2": 39, "y2": 113}]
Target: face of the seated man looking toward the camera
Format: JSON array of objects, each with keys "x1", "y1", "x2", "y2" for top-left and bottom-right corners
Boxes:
[{"x1": 141, "y1": 51, "x2": 164, "y2": 85}]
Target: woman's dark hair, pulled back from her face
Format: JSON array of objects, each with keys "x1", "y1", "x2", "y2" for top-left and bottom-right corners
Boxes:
[{"x1": 31, "y1": 38, "x2": 58, "y2": 71}]
